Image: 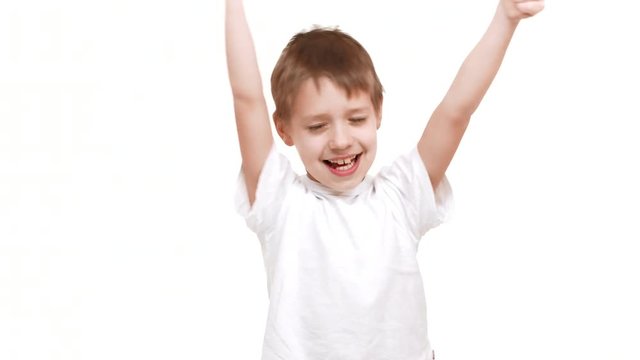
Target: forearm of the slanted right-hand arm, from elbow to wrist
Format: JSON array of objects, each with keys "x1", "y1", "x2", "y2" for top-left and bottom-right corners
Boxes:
[{"x1": 439, "y1": 6, "x2": 518, "y2": 120}]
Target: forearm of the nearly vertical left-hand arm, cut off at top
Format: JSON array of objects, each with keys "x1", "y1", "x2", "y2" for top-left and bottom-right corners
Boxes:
[{"x1": 225, "y1": 0, "x2": 264, "y2": 101}]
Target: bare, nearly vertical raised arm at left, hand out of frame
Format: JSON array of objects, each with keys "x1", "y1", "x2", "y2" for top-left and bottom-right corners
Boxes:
[{"x1": 225, "y1": 0, "x2": 273, "y2": 204}]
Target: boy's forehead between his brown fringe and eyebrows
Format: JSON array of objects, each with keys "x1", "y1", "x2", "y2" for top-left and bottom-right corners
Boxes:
[{"x1": 292, "y1": 77, "x2": 373, "y2": 118}]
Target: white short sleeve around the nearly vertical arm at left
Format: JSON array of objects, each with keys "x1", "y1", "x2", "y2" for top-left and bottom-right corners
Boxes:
[{"x1": 235, "y1": 146, "x2": 296, "y2": 234}]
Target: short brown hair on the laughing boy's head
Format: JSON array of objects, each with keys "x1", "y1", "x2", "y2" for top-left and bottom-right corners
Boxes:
[{"x1": 271, "y1": 27, "x2": 383, "y2": 121}]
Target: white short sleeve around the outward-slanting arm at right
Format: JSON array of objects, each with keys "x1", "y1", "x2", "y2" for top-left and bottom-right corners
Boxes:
[{"x1": 378, "y1": 148, "x2": 453, "y2": 239}]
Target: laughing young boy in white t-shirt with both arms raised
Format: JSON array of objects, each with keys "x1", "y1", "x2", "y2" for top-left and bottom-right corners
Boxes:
[{"x1": 226, "y1": 0, "x2": 544, "y2": 360}]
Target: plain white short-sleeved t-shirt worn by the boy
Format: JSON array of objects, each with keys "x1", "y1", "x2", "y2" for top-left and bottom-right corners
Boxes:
[{"x1": 237, "y1": 146, "x2": 452, "y2": 360}]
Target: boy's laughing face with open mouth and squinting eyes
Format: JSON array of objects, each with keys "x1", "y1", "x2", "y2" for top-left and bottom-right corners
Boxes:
[{"x1": 276, "y1": 78, "x2": 381, "y2": 191}]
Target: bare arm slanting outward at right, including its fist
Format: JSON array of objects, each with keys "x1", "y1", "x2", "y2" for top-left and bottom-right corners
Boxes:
[{"x1": 418, "y1": 0, "x2": 544, "y2": 189}]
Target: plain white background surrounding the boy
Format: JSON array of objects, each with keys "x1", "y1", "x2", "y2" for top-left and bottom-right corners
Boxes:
[{"x1": 0, "y1": 0, "x2": 640, "y2": 360}]
